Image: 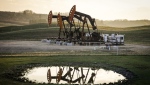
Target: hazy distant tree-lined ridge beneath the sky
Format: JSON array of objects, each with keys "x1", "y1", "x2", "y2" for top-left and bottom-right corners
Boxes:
[{"x1": 0, "y1": 11, "x2": 150, "y2": 28}]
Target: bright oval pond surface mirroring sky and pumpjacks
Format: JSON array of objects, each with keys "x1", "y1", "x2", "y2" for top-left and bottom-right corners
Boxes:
[{"x1": 23, "y1": 66, "x2": 126, "y2": 84}]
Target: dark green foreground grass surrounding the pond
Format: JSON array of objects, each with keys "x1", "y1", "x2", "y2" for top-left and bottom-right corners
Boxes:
[{"x1": 0, "y1": 55, "x2": 150, "y2": 85}]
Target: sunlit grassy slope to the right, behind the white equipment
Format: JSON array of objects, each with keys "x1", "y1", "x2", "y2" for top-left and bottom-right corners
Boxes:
[{"x1": 98, "y1": 26, "x2": 150, "y2": 45}]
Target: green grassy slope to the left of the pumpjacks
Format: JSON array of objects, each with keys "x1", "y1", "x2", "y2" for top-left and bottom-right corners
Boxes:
[{"x1": 0, "y1": 23, "x2": 58, "y2": 40}]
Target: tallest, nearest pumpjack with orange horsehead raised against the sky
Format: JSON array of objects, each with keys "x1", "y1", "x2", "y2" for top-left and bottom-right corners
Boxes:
[{"x1": 69, "y1": 5, "x2": 100, "y2": 41}]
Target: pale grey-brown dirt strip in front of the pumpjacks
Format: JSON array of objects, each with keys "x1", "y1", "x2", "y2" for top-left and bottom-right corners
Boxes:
[{"x1": 0, "y1": 40, "x2": 150, "y2": 55}]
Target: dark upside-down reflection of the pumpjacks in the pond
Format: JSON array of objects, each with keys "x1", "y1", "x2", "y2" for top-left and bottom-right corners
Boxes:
[{"x1": 47, "y1": 67, "x2": 99, "y2": 84}]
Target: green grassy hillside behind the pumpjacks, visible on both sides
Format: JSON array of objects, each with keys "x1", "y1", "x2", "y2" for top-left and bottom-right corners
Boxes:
[{"x1": 0, "y1": 23, "x2": 150, "y2": 45}]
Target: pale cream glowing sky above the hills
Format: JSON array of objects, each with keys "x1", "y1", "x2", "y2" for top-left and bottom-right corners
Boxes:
[{"x1": 0, "y1": 0, "x2": 150, "y2": 20}]
